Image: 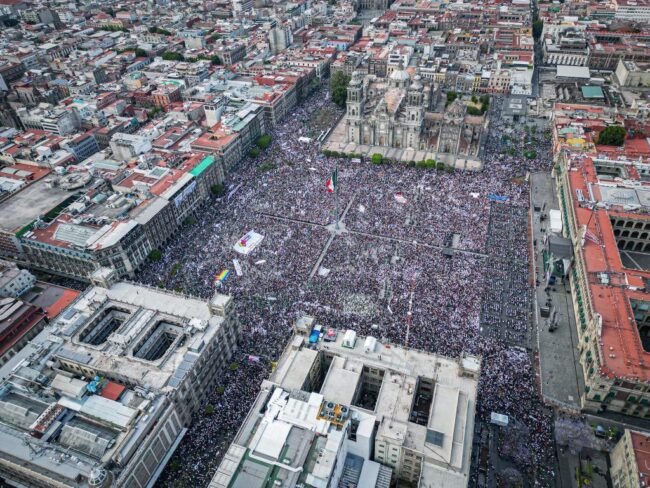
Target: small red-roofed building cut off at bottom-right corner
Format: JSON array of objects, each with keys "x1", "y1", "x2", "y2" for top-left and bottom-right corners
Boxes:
[{"x1": 610, "y1": 429, "x2": 650, "y2": 488}]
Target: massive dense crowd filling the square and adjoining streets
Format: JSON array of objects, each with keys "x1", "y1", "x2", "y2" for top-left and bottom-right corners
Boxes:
[{"x1": 149, "y1": 86, "x2": 552, "y2": 486}]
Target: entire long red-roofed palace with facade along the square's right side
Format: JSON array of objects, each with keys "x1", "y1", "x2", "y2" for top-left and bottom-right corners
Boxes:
[{"x1": 554, "y1": 108, "x2": 650, "y2": 418}]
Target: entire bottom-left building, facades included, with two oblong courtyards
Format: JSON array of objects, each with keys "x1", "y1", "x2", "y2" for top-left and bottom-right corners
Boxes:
[{"x1": 0, "y1": 269, "x2": 238, "y2": 488}]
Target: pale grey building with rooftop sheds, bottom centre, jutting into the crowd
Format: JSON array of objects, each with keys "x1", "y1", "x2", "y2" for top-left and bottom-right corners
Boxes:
[{"x1": 209, "y1": 316, "x2": 480, "y2": 488}]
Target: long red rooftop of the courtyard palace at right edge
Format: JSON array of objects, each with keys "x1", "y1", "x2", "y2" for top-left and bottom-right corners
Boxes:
[{"x1": 569, "y1": 155, "x2": 650, "y2": 382}]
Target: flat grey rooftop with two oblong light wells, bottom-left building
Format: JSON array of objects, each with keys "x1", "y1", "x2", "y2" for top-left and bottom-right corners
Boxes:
[{"x1": 0, "y1": 283, "x2": 230, "y2": 487}]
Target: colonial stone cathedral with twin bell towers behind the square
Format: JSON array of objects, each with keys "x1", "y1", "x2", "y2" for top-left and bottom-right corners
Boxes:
[{"x1": 344, "y1": 70, "x2": 485, "y2": 159}]
